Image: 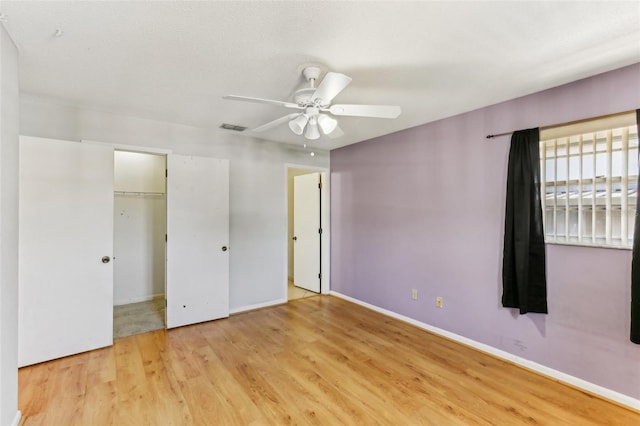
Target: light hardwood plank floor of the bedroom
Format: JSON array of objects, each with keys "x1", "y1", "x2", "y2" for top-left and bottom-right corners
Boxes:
[{"x1": 19, "y1": 296, "x2": 640, "y2": 426}]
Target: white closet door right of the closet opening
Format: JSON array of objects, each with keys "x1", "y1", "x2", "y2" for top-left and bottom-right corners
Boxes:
[{"x1": 166, "y1": 154, "x2": 229, "y2": 328}]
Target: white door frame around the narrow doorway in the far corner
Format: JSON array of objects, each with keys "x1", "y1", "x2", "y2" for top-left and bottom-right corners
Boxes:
[{"x1": 282, "y1": 163, "x2": 331, "y2": 301}]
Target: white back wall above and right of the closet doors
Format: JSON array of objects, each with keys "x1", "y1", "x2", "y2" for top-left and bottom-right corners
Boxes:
[{"x1": 20, "y1": 95, "x2": 329, "y2": 312}]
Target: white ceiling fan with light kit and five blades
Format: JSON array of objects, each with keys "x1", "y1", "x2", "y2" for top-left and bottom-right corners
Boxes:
[{"x1": 223, "y1": 67, "x2": 401, "y2": 139}]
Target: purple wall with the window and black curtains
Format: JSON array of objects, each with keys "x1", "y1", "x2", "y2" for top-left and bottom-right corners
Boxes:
[{"x1": 331, "y1": 64, "x2": 640, "y2": 399}]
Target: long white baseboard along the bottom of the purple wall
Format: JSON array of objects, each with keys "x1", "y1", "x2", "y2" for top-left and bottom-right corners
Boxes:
[{"x1": 330, "y1": 291, "x2": 640, "y2": 410}]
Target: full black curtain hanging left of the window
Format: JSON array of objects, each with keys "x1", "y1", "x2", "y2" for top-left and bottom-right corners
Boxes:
[{"x1": 502, "y1": 128, "x2": 548, "y2": 314}]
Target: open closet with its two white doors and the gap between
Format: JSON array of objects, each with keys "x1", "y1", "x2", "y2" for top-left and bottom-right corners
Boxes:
[{"x1": 18, "y1": 136, "x2": 230, "y2": 367}]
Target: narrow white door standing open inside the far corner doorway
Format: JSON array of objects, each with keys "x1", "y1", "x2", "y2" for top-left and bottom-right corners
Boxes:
[{"x1": 293, "y1": 173, "x2": 322, "y2": 293}]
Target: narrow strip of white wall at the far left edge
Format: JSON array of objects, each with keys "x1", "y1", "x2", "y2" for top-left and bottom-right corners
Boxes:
[{"x1": 0, "y1": 25, "x2": 20, "y2": 425}]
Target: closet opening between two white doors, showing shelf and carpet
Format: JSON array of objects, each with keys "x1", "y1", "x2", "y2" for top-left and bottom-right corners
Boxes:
[{"x1": 113, "y1": 150, "x2": 167, "y2": 338}]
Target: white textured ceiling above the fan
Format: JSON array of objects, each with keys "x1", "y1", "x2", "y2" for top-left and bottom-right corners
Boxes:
[{"x1": 0, "y1": 1, "x2": 640, "y2": 149}]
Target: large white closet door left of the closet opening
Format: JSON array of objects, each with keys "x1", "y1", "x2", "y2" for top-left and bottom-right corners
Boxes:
[{"x1": 18, "y1": 137, "x2": 113, "y2": 366}]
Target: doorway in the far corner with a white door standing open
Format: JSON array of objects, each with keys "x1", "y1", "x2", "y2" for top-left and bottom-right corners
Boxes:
[{"x1": 287, "y1": 166, "x2": 328, "y2": 300}]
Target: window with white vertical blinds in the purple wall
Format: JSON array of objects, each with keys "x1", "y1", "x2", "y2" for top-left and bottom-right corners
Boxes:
[{"x1": 540, "y1": 112, "x2": 638, "y2": 248}]
